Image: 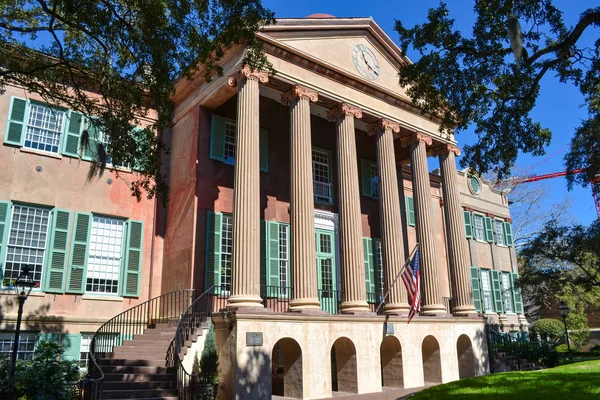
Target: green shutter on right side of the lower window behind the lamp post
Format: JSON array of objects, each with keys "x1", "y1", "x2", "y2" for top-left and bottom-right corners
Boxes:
[{"x1": 42, "y1": 208, "x2": 71, "y2": 293}]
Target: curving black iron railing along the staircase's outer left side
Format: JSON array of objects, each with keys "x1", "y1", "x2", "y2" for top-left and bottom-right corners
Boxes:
[{"x1": 79, "y1": 289, "x2": 196, "y2": 400}]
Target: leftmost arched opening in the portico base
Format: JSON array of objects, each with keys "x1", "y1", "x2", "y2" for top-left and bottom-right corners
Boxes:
[{"x1": 271, "y1": 338, "x2": 304, "y2": 399}]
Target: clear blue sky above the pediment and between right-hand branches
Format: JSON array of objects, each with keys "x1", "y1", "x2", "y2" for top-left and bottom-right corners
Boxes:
[{"x1": 263, "y1": 0, "x2": 598, "y2": 224}]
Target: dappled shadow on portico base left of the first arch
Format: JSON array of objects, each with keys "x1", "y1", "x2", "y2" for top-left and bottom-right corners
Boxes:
[{"x1": 236, "y1": 348, "x2": 271, "y2": 399}]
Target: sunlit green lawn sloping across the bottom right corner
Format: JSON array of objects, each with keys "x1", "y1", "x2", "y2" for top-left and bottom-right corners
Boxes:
[{"x1": 411, "y1": 360, "x2": 600, "y2": 400}]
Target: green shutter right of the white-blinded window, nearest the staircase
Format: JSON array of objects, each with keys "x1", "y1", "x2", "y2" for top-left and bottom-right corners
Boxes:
[{"x1": 120, "y1": 220, "x2": 144, "y2": 297}]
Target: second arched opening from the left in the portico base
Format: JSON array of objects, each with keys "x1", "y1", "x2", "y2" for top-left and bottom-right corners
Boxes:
[{"x1": 331, "y1": 337, "x2": 358, "y2": 393}]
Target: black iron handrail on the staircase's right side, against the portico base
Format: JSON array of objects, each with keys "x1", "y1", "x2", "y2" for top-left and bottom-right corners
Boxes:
[{"x1": 175, "y1": 286, "x2": 229, "y2": 399}]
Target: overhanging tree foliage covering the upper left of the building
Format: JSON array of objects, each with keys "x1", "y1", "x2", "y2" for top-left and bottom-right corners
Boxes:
[{"x1": 0, "y1": 0, "x2": 273, "y2": 202}]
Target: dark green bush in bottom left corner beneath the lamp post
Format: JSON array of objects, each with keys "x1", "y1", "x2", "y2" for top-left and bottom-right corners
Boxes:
[{"x1": 0, "y1": 341, "x2": 80, "y2": 400}]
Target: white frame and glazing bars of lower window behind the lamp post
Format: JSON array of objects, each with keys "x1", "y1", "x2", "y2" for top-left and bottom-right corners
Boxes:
[{"x1": 1, "y1": 203, "x2": 52, "y2": 289}]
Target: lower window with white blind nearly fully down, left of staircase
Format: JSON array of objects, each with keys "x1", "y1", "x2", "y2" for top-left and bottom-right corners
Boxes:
[{"x1": 86, "y1": 216, "x2": 125, "y2": 294}]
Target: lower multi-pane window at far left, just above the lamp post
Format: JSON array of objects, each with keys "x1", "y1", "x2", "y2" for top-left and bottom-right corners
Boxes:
[{"x1": 3, "y1": 204, "x2": 50, "y2": 286}]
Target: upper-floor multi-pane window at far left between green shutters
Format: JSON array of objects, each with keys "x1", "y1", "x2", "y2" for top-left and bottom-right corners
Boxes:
[{"x1": 24, "y1": 102, "x2": 65, "y2": 154}]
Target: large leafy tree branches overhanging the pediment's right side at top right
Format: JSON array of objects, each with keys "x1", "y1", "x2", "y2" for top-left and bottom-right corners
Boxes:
[{"x1": 395, "y1": 0, "x2": 600, "y2": 192}]
